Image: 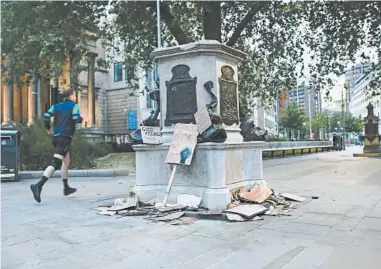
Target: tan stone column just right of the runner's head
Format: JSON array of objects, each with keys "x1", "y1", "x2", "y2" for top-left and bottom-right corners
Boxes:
[{"x1": 87, "y1": 53, "x2": 96, "y2": 128}]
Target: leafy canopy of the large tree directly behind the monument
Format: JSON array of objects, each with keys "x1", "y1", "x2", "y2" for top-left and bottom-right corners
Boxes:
[{"x1": 109, "y1": 1, "x2": 381, "y2": 107}]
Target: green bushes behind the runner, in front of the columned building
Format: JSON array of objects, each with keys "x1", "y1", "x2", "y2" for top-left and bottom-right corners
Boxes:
[{"x1": 18, "y1": 120, "x2": 112, "y2": 170}]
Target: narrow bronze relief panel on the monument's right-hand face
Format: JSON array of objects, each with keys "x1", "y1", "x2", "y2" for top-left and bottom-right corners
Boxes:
[{"x1": 218, "y1": 65, "x2": 239, "y2": 126}]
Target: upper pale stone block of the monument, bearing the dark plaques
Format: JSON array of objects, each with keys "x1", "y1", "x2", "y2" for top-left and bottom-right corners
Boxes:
[{"x1": 152, "y1": 40, "x2": 246, "y2": 143}]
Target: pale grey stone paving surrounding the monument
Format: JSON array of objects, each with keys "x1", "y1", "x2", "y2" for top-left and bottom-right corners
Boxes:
[{"x1": 1, "y1": 147, "x2": 381, "y2": 269}]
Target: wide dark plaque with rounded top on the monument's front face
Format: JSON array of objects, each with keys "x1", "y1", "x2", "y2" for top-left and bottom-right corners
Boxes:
[{"x1": 165, "y1": 65, "x2": 197, "y2": 126}]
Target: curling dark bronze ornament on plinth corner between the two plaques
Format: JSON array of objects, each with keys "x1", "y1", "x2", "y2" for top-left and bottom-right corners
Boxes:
[{"x1": 197, "y1": 81, "x2": 227, "y2": 143}]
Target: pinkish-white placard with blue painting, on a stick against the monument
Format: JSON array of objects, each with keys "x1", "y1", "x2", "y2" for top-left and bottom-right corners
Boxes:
[{"x1": 165, "y1": 123, "x2": 198, "y2": 165}]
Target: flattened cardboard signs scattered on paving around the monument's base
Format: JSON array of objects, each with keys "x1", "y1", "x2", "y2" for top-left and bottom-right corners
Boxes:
[{"x1": 95, "y1": 181, "x2": 307, "y2": 225}]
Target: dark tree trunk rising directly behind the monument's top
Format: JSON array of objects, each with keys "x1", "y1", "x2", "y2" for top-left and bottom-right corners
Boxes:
[{"x1": 201, "y1": 1, "x2": 221, "y2": 42}]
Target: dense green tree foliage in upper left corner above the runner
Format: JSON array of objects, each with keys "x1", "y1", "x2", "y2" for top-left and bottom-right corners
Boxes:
[{"x1": 1, "y1": 1, "x2": 104, "y2": 86}]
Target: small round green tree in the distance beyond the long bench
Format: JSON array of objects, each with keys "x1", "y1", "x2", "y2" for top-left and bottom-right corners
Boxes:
[{"x1": 280, "y1": 102, "x2": 306, "y2": 139}]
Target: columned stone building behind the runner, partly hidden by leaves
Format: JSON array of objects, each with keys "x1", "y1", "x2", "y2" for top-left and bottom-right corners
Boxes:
[{"x1": 1, "y1": 37, "x2": 156, "y2": 143}]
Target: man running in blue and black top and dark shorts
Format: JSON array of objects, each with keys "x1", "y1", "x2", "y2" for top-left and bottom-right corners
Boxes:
[{"x1": 30, "y1": 88, "x2": 82, "y2": 203}]
